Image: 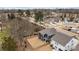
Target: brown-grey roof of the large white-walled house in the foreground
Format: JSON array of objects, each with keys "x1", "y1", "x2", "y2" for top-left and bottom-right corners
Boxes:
[{"x1": 51, "y1": 32, "x2": 73, "y2": 46}]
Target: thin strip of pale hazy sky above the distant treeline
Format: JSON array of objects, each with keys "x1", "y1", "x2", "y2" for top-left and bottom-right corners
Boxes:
[{"x1": 0, "y1": 7, "x2": 79, "y2": 9}]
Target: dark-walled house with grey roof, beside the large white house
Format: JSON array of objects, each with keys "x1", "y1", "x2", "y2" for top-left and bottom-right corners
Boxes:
[{"x1": 38, "y1": 28, "x2": 56, "y2": 41}]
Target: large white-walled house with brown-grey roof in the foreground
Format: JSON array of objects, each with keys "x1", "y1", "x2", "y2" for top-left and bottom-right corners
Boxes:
[{"x1": 51, "y1": 32, "x2": 79, "y2": 51}]
